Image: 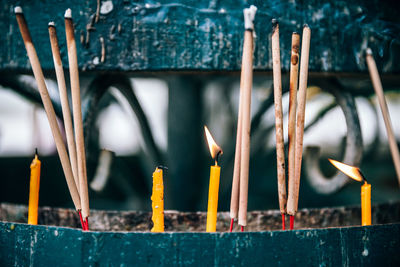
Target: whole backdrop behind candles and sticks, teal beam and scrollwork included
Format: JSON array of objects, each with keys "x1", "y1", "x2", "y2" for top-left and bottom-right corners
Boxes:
[{"x1": 0, "y1": 0, "x2": 400, "y2": 214}]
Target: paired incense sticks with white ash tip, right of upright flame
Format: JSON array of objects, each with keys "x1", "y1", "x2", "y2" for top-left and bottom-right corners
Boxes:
[{"x1": 230, "y1": 6, "x2": 257, "y2": 232}]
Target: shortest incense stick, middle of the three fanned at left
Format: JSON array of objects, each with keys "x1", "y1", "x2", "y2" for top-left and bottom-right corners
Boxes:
[{"x1": 49, "y1": 22, "x2": 79, "y2": 191}]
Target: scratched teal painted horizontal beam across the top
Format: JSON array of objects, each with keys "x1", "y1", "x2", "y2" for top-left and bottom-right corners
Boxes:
[{"x1": 0, "y1": 0, "x2": 400, "y2": 73}]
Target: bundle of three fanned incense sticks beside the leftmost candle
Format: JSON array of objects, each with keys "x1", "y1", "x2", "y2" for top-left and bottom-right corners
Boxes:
[{"x1": 14, "y1": 7, "x2": 89, "y2": 230}]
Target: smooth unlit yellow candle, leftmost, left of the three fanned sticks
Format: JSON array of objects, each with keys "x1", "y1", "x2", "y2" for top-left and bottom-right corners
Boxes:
[{"x1": 28, "y1": 154, "x2": 41, "y2": 225}]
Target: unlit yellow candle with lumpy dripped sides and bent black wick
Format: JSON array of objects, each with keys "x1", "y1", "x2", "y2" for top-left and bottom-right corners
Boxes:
[{"x1": 151, "y1": 167, "x2": 164, "y2": 232}]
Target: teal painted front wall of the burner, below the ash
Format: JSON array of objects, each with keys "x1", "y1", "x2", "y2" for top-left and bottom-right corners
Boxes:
[{"x1": 0, "y1": 222, "x2": 400, "y2": 266}]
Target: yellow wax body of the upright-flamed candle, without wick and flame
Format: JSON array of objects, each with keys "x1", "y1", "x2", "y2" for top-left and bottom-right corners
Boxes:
[{"x1": 206, "y1": 165, "x2": 221, "y2": 232}]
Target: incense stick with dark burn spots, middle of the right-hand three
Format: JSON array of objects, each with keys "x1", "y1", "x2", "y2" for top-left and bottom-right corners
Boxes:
[{"x1": 288, "y1": 32, "x2": 300, "y2": 230}]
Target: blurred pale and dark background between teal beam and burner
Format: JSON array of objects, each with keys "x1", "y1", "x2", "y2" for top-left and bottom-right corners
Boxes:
[{"x1": 0, "y1": 74, "x2": 400, "y2": 210}]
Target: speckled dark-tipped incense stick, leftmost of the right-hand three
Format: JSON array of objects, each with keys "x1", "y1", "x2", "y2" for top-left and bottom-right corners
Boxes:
[{"x1": 271, "y1": 19, "x2": 287, "y2": 229}]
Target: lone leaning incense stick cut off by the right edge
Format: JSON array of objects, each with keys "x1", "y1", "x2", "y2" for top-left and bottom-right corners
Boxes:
[{"x1": 366, "y1": 48, "x2": 400, "y2": 186}]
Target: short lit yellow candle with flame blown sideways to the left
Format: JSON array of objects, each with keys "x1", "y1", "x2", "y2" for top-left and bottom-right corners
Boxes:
[{"x1": 329, "y1": 159, "x2": 371, "y2": 226}]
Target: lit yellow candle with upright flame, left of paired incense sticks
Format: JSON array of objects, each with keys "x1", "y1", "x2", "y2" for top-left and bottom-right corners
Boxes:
[{"x1": 204, "y1": 126, "x2": 222, "y2": 232}]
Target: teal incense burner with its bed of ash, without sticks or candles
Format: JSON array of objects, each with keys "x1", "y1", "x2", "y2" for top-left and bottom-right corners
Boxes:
[{"x1": 0, "y1": 202, "x2": 400, "y2": 266}]
